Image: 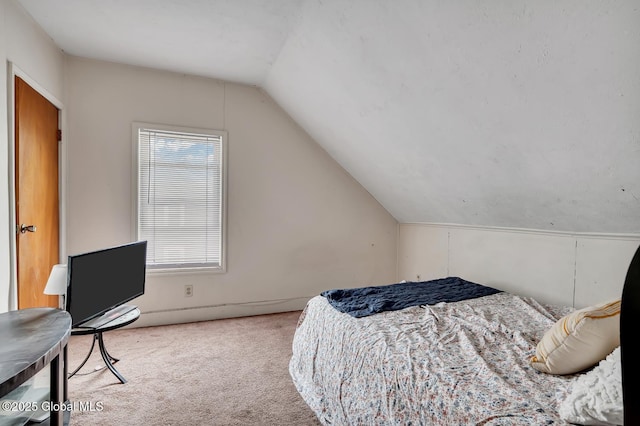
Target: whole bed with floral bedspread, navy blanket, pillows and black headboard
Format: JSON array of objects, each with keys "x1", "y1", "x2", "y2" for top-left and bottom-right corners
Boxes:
[{"x1": 289, "y1": 245, "x2": 640, "y2": 425}]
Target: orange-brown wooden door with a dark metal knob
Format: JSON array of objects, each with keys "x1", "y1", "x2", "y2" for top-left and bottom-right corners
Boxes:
[{"x1": 14, "y1": 77, "x2": 59, "y2": 309}]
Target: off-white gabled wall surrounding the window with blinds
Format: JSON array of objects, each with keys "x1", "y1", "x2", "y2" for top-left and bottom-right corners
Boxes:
[{"x1": 67, "y1": 57, "x2": 397, "y2": 326}]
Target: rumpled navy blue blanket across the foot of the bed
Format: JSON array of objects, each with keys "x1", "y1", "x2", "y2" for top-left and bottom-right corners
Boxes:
[{"x1": 320, "y1": 277, "x2": 500, "y2": 318}]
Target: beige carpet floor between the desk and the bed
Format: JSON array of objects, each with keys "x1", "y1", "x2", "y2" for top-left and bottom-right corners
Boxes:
[{"x1": 68, "y1": 312, "x2": 320, "y2": 426}]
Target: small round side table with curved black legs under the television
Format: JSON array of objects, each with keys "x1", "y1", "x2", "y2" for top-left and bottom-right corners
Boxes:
[{"x1": 69, "y1": 305, "x2": 140, "y2": 384}]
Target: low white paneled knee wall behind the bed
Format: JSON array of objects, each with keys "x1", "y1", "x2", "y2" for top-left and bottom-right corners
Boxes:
[{"x1": 398, "y1": 224, "x2": 640, "y2": 308}]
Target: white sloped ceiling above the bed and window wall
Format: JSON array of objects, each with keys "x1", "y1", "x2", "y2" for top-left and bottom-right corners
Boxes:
[{"x1": 19, "y1": 0, "x2": 640, "y2": 233}]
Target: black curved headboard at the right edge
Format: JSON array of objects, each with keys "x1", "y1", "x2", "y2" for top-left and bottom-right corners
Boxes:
[{"x1": 620, "y1": 247, "x2": 640, "y2": 425}]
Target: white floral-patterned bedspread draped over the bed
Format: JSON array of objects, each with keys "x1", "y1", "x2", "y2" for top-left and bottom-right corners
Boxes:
[{"x1": 289, "y1": 293, "x2": 576, "y2": 425}]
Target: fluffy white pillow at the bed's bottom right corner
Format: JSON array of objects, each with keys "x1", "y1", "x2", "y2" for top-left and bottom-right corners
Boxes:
[{"x1": 558, "y1": 346, "x2": 624, "y2": 425}]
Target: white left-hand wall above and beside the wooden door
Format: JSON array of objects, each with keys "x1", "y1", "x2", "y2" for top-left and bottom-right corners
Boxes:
[{"x1": 0, "y1": 0, "x2": 64, "y2": 312}]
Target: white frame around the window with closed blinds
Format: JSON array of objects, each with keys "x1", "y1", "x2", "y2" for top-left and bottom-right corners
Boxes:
[{"x1": 131, "y1": 121, "x2": 228, "y2": 274}]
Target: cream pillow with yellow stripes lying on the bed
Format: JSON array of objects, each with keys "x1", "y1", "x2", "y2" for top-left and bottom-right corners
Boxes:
[{"x1": 531, "y1": 299, "x2": 620, "y2": 374}]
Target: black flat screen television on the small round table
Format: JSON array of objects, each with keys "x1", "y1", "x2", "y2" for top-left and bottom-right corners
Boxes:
[{"x1": 65, "y1": 241, "x2": 147, "y2": 327}]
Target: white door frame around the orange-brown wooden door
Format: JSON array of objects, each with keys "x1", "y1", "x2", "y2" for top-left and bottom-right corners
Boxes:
[{"x1": 7, "y1": 62, "x2": 67, "y2": 311}]
